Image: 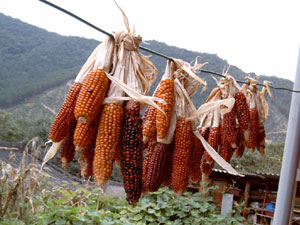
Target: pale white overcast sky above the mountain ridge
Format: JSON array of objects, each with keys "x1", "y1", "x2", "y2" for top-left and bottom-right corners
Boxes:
[{"x1": 0, "y1": 0, "x2": 300, "y2": 81}]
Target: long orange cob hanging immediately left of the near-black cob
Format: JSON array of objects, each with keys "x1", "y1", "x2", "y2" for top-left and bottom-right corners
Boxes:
[{"x1": 93, "y1": 103, "x2": 124, "y2": 187}]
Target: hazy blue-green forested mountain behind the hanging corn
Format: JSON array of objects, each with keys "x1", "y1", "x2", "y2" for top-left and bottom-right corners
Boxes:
[{"x1": 0, "y1": 14, "x2": 293, "y2": 141}]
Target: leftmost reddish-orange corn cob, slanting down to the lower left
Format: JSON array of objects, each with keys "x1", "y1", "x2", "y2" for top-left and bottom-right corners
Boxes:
[{"x1": 49, "y1": 82, "x2": 82, "y2": 142}]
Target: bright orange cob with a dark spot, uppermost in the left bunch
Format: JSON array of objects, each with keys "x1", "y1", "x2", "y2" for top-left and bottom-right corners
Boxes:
[{"x1": 74, "y1": 69, "x2": 109, "y2": 123}]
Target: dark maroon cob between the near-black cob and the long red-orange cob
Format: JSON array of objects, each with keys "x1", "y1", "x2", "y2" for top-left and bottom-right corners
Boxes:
[{"x1": 145, "y1": 143, "x2": 169, "y2": 192}]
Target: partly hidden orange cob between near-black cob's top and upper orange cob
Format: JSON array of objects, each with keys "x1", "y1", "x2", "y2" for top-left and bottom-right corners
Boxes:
[{"x1": 143, "y1": 105, "x2": 156, "y2": 143}]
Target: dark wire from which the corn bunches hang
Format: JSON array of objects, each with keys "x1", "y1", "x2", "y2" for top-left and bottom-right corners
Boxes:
[{"x1": 39, "y1": 0, "x2": 300, "y2": 93}]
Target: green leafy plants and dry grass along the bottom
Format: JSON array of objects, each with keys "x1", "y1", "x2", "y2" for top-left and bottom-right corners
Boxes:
[{"x1": 0, "y1": 149, "x2": 244, "y2": 225}]
